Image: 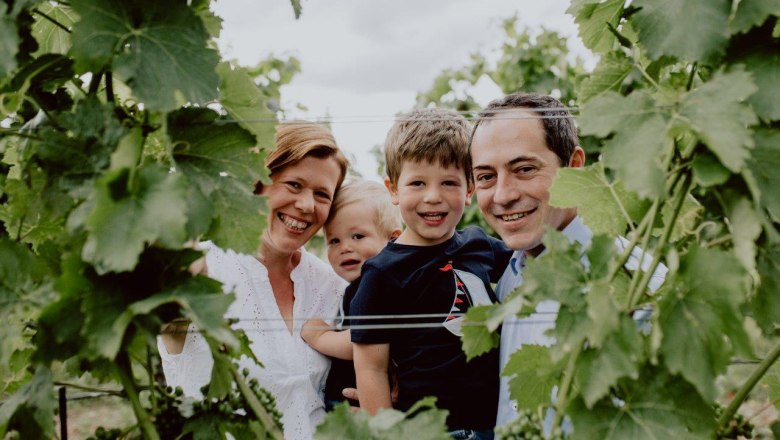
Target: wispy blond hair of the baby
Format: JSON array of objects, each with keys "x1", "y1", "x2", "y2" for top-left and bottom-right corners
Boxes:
[{"x1": 325, "y1": 179, "x2": 403, "y2": 237}]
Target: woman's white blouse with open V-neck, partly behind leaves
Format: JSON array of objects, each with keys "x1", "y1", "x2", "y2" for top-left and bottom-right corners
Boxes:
[{"x1": 157, "y1": 242, "x2": 347, "y2": 440}]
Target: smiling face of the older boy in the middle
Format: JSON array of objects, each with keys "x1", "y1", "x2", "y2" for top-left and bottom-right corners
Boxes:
[{"x1": 385, "y1": 161, "x2": 473, "y2": 246}]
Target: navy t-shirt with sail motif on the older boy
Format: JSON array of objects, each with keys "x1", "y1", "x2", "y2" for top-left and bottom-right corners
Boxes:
[{"x1": 350, "y1": 227, "x2": 512, "y2": 430}]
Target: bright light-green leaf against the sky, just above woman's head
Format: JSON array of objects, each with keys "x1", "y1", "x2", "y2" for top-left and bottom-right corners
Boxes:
[{"x1": 217, "y1": 63, "x2": 276, "y2": 159}]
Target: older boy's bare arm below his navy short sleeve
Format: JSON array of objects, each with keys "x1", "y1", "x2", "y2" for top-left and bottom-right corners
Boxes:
[{"x1": 353, "y1": 343, "x2": 393, "y2": 415}]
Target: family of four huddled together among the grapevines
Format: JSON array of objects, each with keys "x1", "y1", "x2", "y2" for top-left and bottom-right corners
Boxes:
[{"x1": 158, "y1": 93, "x2": 666, "y2": 439}]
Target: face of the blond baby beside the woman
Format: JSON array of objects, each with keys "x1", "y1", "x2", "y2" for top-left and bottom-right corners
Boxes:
[{"x1": 325, "y1": 203, "x2": 390, "y2": 282}]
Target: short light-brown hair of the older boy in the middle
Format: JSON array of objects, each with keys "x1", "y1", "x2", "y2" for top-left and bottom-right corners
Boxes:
[{"x1": 384, "y1": 108, "x2": 473, "y2": 185}]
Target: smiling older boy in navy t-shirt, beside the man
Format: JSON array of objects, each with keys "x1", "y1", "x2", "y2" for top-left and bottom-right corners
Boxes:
[{"x1": 350, "y1": 109, "x2": 511, "y2": 438}]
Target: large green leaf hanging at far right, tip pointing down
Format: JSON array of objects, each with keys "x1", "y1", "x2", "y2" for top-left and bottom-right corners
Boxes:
[{"x1": 658, "y1": 247, "x2": 750, "y2": 400}]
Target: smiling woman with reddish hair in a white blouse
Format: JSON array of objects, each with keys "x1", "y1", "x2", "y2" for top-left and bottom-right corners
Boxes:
[{"x1": 158, "y1": 122, "x2": 348, "y2": 439}]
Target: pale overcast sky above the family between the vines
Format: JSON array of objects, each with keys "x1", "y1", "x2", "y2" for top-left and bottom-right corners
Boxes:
[{"x1": 213, "y1": 0, "x2": 585, "y2": 179}]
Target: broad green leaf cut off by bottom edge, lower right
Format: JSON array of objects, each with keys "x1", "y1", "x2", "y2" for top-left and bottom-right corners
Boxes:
[{"x1": 567, "y1": 367, "x2": 715, "y2": 440}]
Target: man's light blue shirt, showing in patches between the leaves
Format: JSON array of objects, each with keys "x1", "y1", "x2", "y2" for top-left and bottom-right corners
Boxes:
[{"x1": 496, "y1": 217, "x2": 669, "y2": 426}]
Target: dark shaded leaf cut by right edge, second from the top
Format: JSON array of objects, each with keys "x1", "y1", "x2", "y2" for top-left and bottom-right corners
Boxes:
[{"x1": 733, "y1": 44, "x2": 780, "y2": 121}]
